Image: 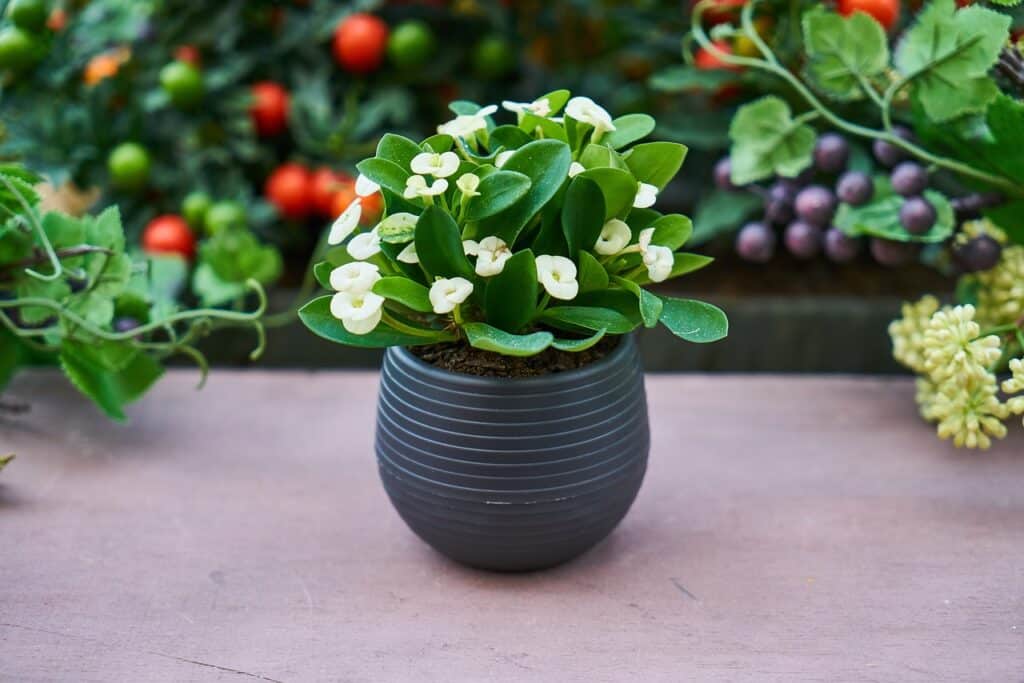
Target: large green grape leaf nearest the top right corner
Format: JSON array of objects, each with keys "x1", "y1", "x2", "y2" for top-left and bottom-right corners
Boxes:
[{"x1": 894, "y1": 0, "x2": 1011, "y2": 122}]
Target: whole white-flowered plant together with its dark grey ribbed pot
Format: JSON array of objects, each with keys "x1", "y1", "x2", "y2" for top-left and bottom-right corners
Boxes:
[{"x1": 300, "y1": 90, "x2": 727, "y2": 570}]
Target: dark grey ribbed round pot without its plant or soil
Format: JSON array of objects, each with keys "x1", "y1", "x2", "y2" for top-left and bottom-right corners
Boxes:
[{"x1": 376, "y1": 337, "x2": 650, "y2": 571}]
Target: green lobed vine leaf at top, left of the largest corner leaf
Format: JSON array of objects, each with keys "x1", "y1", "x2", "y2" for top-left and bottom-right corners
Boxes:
[{"x1": 803, "y1": 7, "x2": 889, "y2": 99}]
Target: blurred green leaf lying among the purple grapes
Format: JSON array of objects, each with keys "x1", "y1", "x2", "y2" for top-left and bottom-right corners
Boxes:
[{"x1": 833, "y1": 189, "x2": 955, "y2": 244}]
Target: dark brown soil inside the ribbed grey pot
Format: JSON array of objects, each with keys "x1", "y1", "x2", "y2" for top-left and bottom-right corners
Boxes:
[{"x1": 409, "y1": 337, "x2": 618, "y2": 377}]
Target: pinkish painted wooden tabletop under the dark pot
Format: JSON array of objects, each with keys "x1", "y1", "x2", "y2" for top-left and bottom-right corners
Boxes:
[{"x1": 0, "y1": 372, "x2": 1024, "y2": 682}]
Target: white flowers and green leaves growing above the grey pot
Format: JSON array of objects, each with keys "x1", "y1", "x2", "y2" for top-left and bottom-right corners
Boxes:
[{"x1": 300, "y1": 90, "x2": 726, "y2": 355}]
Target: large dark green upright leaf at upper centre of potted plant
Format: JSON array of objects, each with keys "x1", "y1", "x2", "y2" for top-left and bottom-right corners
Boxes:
[{"x1": 481, "y1": 140, "x2": 572, "y2": 245}]
